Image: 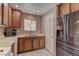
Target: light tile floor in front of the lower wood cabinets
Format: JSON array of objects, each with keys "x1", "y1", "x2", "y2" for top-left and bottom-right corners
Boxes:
[{"x1": 18, "y1": 49, "x2": 52, "y2": 56}]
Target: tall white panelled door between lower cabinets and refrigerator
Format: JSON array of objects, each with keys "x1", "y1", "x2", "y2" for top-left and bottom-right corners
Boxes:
[{"x1": 45, "y1": 14, "x2": 54, "y2": 53}]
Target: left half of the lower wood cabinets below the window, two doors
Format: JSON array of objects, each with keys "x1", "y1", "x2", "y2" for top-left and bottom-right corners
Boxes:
[{"x1": 17, "y1": 37, "x2": 32, "y2": 53}]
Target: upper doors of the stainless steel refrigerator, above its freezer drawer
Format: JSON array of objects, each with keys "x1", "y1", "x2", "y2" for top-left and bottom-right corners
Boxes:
[{"x1": 57, "y1": 11, "x2": 79, "y2": 45}]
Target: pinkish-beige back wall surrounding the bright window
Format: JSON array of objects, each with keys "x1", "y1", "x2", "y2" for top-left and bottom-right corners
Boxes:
[{"x1": 17, "y1": 13, "x2": 43, "y2": 35}]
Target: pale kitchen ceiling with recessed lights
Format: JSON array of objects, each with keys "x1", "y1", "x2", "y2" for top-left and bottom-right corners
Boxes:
[{"x1": 11, "y1": 3, "x2": 57, "y2": 15}]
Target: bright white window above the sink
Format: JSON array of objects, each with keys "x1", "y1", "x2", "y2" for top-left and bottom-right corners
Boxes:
[{"x1": 24, "y1": 19, "x2": 36, "y2": 31}]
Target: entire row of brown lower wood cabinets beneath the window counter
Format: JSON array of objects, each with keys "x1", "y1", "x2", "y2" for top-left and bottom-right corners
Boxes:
[{"x1": 17, "y1": 36, "x2": 45, "y2": 53}]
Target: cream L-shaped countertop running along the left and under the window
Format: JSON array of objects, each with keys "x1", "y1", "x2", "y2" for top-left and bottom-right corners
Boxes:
[{"x1": 0, "y1": 34, "x2": 44, "y2": 47}]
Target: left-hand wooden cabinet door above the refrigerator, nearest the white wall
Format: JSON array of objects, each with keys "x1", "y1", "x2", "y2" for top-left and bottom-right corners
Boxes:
[{"x1": 60, "y1": 3, "x2": 70, "y2": 16}]
